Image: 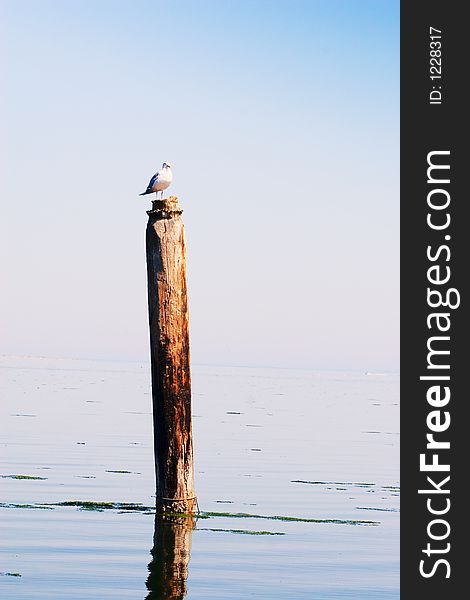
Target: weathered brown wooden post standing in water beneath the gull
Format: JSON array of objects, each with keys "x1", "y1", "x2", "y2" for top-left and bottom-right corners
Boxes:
[{"x1": 146, "y1": 196, "x2": 197, "y2": 514}]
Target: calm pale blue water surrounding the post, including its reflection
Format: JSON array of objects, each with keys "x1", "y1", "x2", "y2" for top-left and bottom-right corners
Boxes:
[{"x1": 0, "y1": 357, "x2": 399, "y2": 600}]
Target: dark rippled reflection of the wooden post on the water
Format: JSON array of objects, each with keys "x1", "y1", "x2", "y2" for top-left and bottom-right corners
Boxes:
[{"x1": 146, "y1": 516, "x2": 196, "y2": 600}]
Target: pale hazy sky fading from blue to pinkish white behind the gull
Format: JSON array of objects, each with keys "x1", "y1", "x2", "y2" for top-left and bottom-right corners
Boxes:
[{"x1": 0, "y1": 0, "x2": 399, "y2": 370}]
